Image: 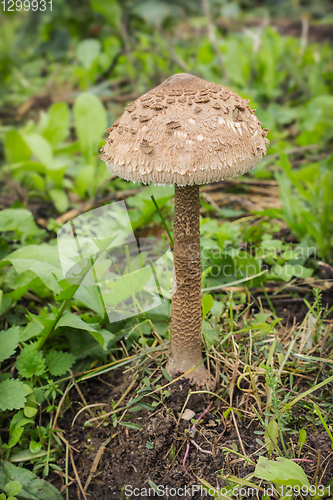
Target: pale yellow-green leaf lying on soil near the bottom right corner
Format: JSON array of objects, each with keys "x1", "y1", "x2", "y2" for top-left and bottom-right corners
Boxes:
[{"x1": 254, "y1": 457, "x2": 310, "y2": 489}]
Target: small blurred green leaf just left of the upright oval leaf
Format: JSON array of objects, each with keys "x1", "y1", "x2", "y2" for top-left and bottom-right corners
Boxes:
[{"x1": 42, "y1": 102, "x2": 69, "y2": 147}]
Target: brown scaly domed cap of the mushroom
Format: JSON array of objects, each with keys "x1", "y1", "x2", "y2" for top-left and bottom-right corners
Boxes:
[{"x1": 102, "y1": 73, "x2": 269, "y2": 186}]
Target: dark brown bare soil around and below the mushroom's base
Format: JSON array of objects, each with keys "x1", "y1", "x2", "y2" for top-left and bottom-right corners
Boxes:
[{"x1": 52, "y1": 370, "x2": 333, "y2": 500}]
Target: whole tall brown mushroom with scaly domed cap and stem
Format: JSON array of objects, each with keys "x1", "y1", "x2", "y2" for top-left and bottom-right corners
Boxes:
[{"x1": 102, "y1": 73, "x2": 268, "y2": 386}]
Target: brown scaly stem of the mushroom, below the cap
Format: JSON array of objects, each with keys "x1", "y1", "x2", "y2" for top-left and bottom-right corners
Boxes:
[{"x1": 167, "y1": 185, "x2": 208, "y2": 386}]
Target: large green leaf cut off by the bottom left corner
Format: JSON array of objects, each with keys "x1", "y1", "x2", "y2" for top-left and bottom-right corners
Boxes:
[{"x1": 0, "y1": 460, "x2": 62, "y2": 500}]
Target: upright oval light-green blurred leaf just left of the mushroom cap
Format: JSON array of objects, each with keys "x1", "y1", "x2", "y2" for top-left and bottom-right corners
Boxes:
[{"x1": 74, "y1": 92, "x2": 107, "y2": 165}]
